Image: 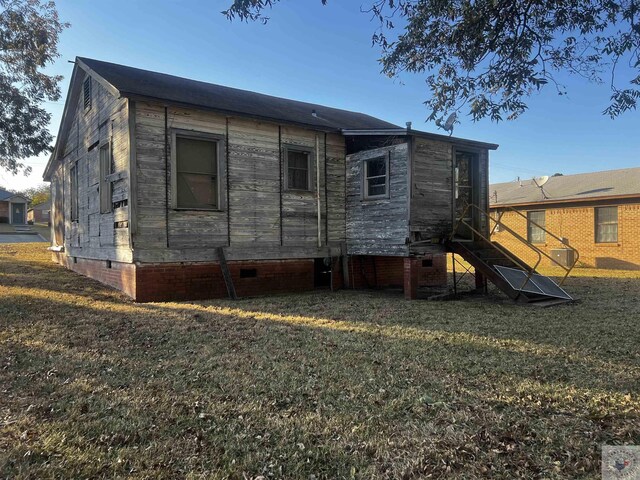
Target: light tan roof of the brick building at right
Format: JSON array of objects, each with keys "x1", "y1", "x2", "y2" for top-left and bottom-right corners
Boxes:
[{"x1": 489, "y1": 168, "x2": 640, "y2": 207}]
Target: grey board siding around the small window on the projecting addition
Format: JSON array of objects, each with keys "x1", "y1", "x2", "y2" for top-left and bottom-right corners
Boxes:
[{"x1": 347, "y1": 143, "x2": 409, "y2": 256}]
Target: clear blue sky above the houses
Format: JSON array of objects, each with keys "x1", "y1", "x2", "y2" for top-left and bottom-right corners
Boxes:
[{"x1": 0, "y1": 0, "x2": 640, "y2": 189}]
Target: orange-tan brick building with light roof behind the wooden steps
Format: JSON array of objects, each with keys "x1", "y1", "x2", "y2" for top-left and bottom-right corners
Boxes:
[{"x1": 489, "y1": 168, "x2": 640, "y2": 270}]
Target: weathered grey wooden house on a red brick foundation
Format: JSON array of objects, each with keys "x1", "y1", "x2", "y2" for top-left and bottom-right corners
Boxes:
[{"x1": 44, "y1": 58, "x2": 568, "y2": 301}]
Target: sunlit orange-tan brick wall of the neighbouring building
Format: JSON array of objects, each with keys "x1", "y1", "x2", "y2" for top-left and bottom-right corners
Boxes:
[{"x1": 492, "y1": 203, "x2": 640, "y2": 270}]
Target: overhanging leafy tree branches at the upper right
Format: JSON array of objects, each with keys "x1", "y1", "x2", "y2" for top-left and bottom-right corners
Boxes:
[{"x1": 222, "y1": 0, "x2": 640, "y2": 125}]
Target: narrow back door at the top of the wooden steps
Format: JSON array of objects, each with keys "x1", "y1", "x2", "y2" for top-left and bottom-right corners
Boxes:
[{"x1": 453, "y1": 151, "x2": 478, "y2": 241}]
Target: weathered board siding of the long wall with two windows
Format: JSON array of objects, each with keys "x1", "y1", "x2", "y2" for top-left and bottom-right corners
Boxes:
[{"x1": 133, "y1": 102, "x2": 345, "y2": 262}]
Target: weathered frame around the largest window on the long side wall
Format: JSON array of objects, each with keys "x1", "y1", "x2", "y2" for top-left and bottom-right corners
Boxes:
[{"x1": 170, "y1": 128, "x2": 226, "y2": 212}]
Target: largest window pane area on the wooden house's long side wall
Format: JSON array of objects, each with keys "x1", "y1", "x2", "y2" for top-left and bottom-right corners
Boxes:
[{"x1": 176, "y1": 136, "x2": 218, "y2": 210}]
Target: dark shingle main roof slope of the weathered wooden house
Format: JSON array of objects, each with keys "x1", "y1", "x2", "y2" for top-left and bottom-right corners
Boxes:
[{"x1": 78, "y1": 57, "x2": 397, "y2": 130}]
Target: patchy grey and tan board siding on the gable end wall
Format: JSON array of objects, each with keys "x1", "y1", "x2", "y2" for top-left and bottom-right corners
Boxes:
[{"x1": 52, "y1": 69, "x2": 132, "y2": 262}]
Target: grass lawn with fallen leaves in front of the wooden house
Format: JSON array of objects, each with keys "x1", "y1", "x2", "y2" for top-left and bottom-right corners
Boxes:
[{"x1": 0, "y1": 244, "x2": 640, "y2": 479}]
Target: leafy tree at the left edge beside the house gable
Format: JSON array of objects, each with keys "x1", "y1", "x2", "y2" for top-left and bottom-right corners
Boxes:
[{"x1": 0, "y1": 0, "x2": 68, "y2": 175}]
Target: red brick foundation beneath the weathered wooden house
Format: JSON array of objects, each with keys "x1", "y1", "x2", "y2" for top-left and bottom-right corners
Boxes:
[{"x1": 53, "y1": 252, "x2": 447, "y2": 302}]
